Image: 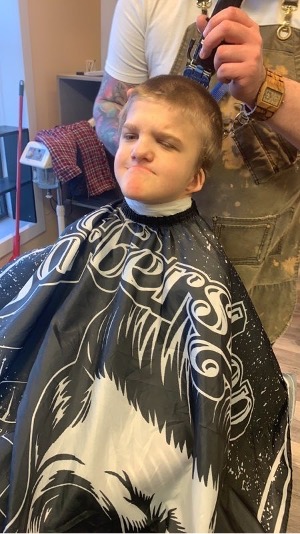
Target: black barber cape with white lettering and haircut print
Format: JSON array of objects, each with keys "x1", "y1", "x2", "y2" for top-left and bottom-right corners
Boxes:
[{"x1": 0, "y1": 201, "x2": 291, "y2": 532}]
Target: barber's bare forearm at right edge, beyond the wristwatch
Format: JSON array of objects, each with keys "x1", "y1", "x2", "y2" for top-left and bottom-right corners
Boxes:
[{"x1": 268, "y1": 78, "x2": 300, "y2": 150}]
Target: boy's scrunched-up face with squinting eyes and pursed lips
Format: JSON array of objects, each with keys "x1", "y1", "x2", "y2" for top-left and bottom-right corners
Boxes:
[{"x1": 115, "y1": 100, "x2": 204, "y2": 204}]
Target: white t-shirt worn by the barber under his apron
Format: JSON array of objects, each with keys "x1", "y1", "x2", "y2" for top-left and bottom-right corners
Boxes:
[{"x1": 105, "y1": 0, "x2": 300, "y2": 84}]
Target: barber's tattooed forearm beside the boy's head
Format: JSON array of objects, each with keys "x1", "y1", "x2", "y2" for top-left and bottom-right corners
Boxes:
[{"x1": 93, "y1": 100, "x2": 122, "y2": 156}]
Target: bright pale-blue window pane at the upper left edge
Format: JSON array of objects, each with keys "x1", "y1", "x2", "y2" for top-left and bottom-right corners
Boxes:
[{"x1": 0, "y1": 0, "x2": 28, "y2": 127}]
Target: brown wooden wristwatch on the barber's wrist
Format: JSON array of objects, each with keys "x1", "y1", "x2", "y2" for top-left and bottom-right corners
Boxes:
[{"x1": 245, "y1": 69, "x2": 284, "y2": 121}]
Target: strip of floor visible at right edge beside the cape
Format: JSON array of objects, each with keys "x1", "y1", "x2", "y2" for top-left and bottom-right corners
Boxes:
[{"x1": 274, "y1": 279, "x2": 300, "y2": 533}]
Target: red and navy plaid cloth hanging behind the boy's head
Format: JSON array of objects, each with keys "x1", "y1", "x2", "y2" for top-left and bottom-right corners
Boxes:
[{"x1": 35, "y1": 121, "x2": 116, "y2": 196}]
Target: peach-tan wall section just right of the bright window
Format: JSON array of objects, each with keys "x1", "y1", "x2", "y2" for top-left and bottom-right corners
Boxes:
[{"x1": 21, "y1": 0, "x2": 101, "y2": 137}]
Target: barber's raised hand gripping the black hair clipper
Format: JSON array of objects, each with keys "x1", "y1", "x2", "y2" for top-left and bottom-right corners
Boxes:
[{"x1": 197, "y1": 7, "x2": 266, "y2": 107}]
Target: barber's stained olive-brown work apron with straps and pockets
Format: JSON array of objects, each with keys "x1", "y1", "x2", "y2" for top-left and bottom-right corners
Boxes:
[{"x1": 171, "y1": 24, "x2": 300, "y2": 342}]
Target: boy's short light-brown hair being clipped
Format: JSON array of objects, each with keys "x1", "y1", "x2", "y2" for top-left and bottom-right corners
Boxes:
[{"x1": 119, "y1": 74, "x2": 223, "y2": 173}]
